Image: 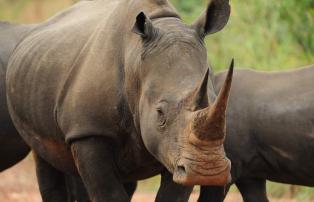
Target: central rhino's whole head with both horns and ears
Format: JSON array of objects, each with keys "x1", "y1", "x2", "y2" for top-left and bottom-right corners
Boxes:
[{"x1": 129, "y1": 0, "x2": 233, "y2": 185}]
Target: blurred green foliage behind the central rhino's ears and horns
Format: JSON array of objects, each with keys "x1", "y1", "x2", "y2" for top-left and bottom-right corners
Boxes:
[{"x1": 173, "y1": 0, "x2": 314, "y2": 70}]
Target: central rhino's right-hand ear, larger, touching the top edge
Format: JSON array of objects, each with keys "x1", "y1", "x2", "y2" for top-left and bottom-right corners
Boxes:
[{"x1": 192, "y1": 0, "x2": 230, "y2": 37}]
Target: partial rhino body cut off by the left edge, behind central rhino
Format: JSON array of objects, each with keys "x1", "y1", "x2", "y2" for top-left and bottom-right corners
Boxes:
[{"x1": 0, "y1": 22, "x2": 34, "y2": 172}]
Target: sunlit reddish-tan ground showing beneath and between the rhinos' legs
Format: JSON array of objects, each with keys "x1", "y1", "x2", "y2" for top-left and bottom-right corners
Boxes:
[{"x1": 0, "y1": 156, "x2": 304, "y2": 202}]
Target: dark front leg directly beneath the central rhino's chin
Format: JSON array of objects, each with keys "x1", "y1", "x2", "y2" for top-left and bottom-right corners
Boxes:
[{"x1": 156, "y1": 171, "x2": 193, "y2": 202}]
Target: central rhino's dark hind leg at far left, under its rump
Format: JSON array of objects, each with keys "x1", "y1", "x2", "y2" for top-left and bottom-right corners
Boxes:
[{"x1": 34, "y1": 153, "x2": 67, "y2": 202}]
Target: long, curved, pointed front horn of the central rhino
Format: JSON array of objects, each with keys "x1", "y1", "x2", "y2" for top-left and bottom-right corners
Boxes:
[{"x1": 192, "y1": 60, "x2": 234, "y2": 141}]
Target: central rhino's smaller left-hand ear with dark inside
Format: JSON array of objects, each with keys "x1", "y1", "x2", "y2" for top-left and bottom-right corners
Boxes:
[{"x1": 132, "y1": 12, "x2": 154, "y2": 39}]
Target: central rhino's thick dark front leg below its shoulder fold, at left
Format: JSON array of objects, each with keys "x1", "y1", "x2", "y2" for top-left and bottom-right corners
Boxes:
[{"x1": 71, "y1": 137, "x2": 130, "y2": 202}]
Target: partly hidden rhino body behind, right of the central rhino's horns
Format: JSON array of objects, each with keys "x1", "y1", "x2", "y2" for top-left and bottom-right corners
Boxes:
[{"x1": 199, "y1": 65, "x2": 314, "y2": 202}]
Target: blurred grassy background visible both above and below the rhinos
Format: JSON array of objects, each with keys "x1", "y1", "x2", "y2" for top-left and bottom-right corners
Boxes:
[{"x1": 0, "y1": 0, "x2": 314, "y2": 202}]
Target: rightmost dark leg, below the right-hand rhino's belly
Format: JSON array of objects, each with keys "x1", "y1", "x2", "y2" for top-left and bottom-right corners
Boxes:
[{"x1": 236, "y1": 179, "x2": 268, "y2": 202}]
